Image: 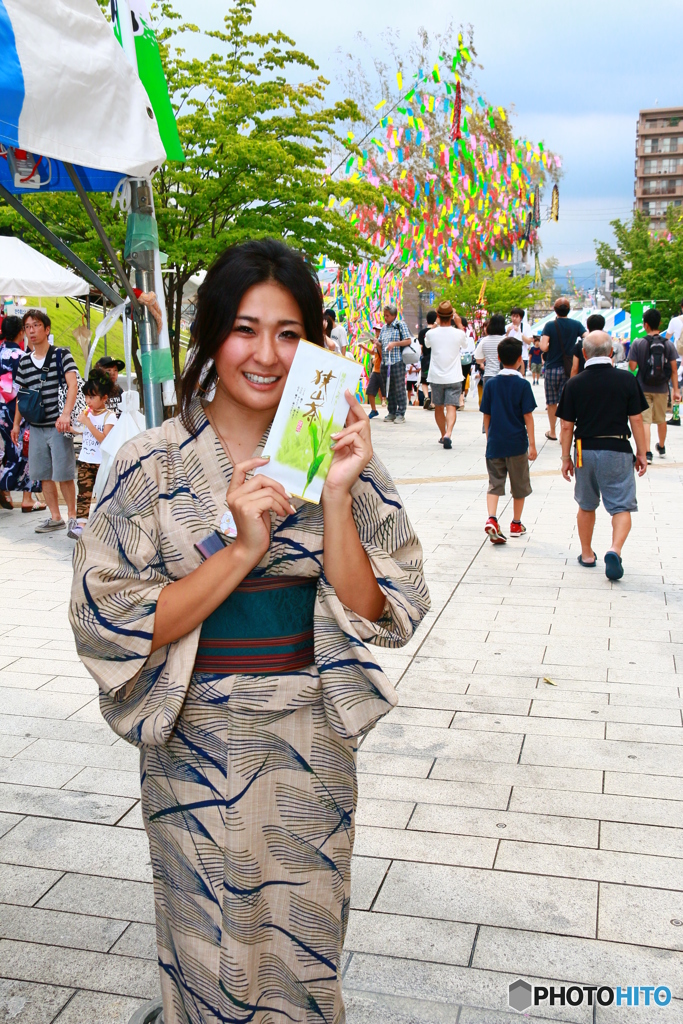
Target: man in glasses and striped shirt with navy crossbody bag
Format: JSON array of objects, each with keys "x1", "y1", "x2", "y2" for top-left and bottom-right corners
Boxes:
[{"x1": 12, "y1": 309, "x2": 78, "y2": 537}]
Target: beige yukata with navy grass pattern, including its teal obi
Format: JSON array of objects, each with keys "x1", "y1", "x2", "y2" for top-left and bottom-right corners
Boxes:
[{"x1": 70, "y1": 400, "x2": 429, "y2": 1024}]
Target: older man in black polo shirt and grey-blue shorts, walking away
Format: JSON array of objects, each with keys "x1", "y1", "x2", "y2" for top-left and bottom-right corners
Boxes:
[{"x1": 557, "y1": 331, "x2": 647, "y2": 580}]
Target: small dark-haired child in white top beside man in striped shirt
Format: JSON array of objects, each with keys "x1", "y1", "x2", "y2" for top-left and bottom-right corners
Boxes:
[{"x1": 73, "y1": 368, "x2": 117, "y2": 538}]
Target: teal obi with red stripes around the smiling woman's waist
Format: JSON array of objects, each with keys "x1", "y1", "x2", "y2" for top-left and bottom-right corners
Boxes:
[{"x1": 195, "y1": 575, "x2": 317, "y2": 676}]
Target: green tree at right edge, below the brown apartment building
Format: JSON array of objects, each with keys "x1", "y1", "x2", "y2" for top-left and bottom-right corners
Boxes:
[{"x1": 595, "y1": 206, "x2": 683, "y2": 317}]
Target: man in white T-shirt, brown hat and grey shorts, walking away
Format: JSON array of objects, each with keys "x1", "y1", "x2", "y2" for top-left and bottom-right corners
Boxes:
[{"x1": 425, "y1": 299, "x2": 467, "y2": 449}]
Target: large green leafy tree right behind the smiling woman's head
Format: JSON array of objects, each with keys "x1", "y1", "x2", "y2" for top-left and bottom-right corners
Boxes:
[{"x1": 0, "y1": 0, "x2": 379, "y2": 389}]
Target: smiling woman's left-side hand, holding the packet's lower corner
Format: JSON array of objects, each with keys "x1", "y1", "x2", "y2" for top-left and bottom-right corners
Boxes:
[{"x1": 226, "y1": 459, "x2": 296, "y2": 568}]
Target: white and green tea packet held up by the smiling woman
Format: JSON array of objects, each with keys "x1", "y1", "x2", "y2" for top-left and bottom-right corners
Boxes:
[{"x1": 255, "y1": 340, "x2": 362, "y2": 504}]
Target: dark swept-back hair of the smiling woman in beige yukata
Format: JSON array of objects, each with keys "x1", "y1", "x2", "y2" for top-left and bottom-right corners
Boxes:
[{"x1": 180, "y1": 239, "x2": 325, "y2": 428}]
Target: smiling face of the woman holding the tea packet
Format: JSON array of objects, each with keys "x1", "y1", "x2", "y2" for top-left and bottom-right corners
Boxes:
[{"x1": 214, "y1": 281, "x2": 304, "y2": 412}]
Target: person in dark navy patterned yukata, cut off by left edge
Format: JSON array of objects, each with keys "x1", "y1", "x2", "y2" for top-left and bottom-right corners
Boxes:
[{"x1": 0, "y1": 316, "x2": 45, "y2": 512}]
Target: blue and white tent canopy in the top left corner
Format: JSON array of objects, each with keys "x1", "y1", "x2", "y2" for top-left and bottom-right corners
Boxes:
[{"x1": 0, "y1": 0, "x2": 166, "y2": 184}]
